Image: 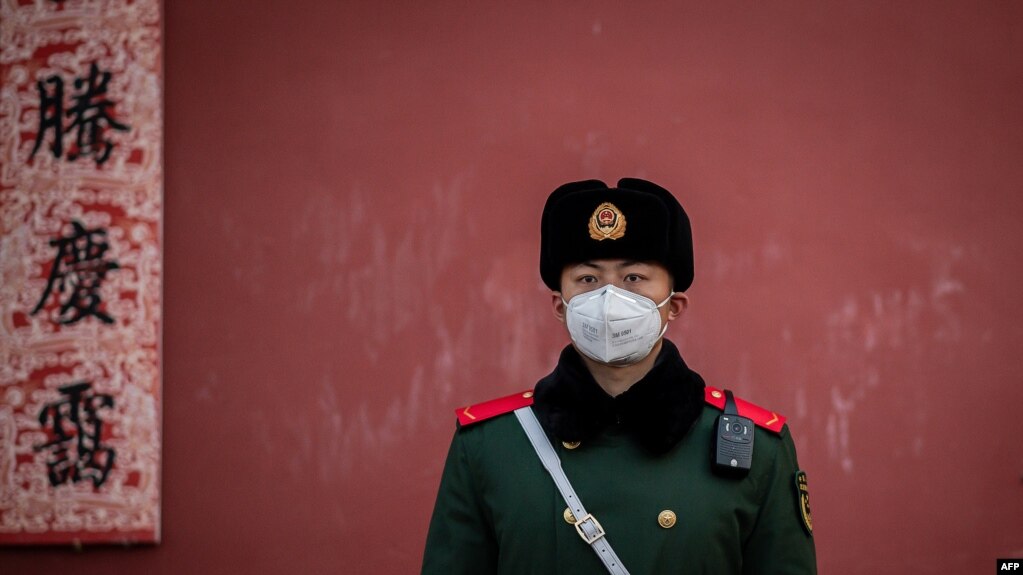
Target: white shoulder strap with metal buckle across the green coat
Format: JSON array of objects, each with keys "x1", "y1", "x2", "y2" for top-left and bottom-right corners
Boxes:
[{"x1": 515, "y1": 407, "x2": 629, "y2": 575}]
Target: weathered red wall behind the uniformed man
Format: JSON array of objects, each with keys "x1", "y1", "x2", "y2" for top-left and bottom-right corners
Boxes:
[{"x1": 0, "y1": 0, "x2": 1023, "y2": 575}]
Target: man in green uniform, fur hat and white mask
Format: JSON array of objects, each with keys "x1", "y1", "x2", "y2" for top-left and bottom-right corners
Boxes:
[{"x1": 422, "y1": 179, "x2": 816, "y2": 575}]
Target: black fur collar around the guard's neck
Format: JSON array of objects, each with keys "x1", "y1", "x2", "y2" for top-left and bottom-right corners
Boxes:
[{"x1": 533, "y1": 340, "x2": 704, "y2": 454}]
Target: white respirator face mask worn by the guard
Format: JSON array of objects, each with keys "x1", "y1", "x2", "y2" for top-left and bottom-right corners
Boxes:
[{"x1": 562, "y1": 284, "x2": 674, "y2": 365}]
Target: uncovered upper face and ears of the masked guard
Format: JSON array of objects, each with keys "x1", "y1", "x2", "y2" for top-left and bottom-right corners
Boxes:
[{"x1": 551, "y1": 255, "x2": 688, "y2": 323}]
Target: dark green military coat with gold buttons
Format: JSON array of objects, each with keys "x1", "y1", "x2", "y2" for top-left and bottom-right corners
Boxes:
[{"x1": 422, "y1": 341, "x2": 816, "y2": 575}]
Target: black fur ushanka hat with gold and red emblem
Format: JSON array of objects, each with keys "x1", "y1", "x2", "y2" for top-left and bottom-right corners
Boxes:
[{"x1": 540, "y1": 178, "x2": 693, "y2": 292}]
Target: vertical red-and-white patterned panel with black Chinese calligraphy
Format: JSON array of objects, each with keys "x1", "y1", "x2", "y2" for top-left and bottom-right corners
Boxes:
[{"x1": 0, "y1": 0, "x2": 163, "y2": 543}]
